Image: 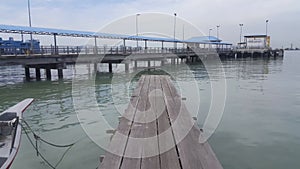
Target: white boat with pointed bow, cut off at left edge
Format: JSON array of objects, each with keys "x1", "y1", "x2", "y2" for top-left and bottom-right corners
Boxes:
[{"x1": 0, "y1": 98, "x2": 33, "y2": 169}]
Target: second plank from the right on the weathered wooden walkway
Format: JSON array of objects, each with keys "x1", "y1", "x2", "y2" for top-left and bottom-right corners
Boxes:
[{"x1": 155, "y1": 76, "x2": 181, "y2": 169}]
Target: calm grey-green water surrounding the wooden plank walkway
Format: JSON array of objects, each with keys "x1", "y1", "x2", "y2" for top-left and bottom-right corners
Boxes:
[{"x1": 0, "y1": 52, "x2": 300, "y2": 169}]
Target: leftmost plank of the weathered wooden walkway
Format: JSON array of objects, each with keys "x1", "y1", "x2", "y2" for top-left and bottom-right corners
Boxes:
[{"x1": 99, "y1": 76, "x2": 145, "y2": 169}]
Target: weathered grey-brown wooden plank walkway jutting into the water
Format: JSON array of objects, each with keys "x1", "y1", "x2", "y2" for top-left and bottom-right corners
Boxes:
[{"x1": 99, "y1": 75, "x2": 222, "y2": 169}]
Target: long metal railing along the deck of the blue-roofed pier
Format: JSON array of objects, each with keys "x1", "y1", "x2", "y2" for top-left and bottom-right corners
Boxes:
[{"x1": 0, "y1": 46, "x2": 232, "y2": 56}]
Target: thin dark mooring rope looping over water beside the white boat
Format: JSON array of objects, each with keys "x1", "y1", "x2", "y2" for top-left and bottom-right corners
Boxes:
[{"x1": 21, "y1": 120, "x2": 79, "y2": 169}]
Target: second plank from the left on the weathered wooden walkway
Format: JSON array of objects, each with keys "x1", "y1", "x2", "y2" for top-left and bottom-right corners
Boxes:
[{"x1": 120, "y1": 76, "x2": 150, "y2": 169}]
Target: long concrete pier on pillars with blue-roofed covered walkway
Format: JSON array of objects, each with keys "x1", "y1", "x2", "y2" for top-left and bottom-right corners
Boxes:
[{"x1": 0, "y1": 24, "x2": 283, "y2": 80}]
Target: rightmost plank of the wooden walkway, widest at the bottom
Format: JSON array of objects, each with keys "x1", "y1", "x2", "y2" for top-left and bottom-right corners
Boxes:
[{"x1": 164, "y1": 78, "x2": 222, "y2": 169}]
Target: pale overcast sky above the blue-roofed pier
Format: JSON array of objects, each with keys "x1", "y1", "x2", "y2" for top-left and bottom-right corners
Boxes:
[{"x1": 0, "y1": 0, "x2": 300, "y2": 47}]
